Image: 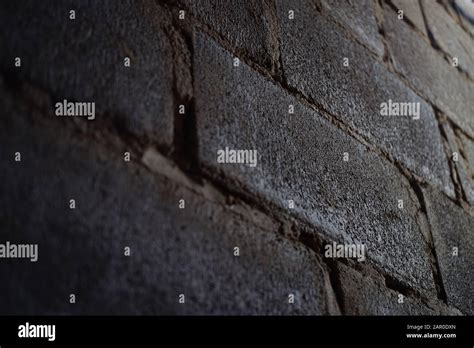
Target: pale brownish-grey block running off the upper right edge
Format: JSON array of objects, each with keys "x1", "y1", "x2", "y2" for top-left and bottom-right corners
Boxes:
[{"x1": 384, "y1": 5, "x2": 474, "y2": 134}]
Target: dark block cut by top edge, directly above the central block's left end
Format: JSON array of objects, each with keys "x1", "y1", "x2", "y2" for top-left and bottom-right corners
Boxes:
[{"x1": 179, "y1": 0, "x2": 277, "y2": 66}]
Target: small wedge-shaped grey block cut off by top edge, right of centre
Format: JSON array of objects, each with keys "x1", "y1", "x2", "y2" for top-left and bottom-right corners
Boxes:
[{"x1": 322, "y1": 0, "x2": 384, "y2": 56}]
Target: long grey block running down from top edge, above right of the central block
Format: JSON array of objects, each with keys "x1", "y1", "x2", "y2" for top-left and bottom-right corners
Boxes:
[{"x1": 277, "y1": 0, "x2": 454, "y2": 196}]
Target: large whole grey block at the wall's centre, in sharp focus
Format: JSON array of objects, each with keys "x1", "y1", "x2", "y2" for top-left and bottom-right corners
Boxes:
[{"x1": 194, "y1": 34, "x2": 434, "y2": 291}]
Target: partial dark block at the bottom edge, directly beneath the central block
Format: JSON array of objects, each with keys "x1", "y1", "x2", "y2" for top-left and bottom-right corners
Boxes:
[{"x1": 337, "y1": 263, "x2": 461, "y2": 315}]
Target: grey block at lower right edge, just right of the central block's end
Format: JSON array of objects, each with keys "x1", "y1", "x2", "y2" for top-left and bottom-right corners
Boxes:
[{"x1": 424, "y1": 189, "x2": 474, "y2": 315}]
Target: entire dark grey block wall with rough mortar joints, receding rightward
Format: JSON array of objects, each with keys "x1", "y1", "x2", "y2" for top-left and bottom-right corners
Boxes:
[{"x1": 0, "y1": 0, "x2": 474, "y2": 315}]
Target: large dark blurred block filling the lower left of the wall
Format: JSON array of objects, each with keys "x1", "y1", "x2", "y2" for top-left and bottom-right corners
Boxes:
[{"x1": 0, "y1": 83, "x2": 336, "y2": 314}]
